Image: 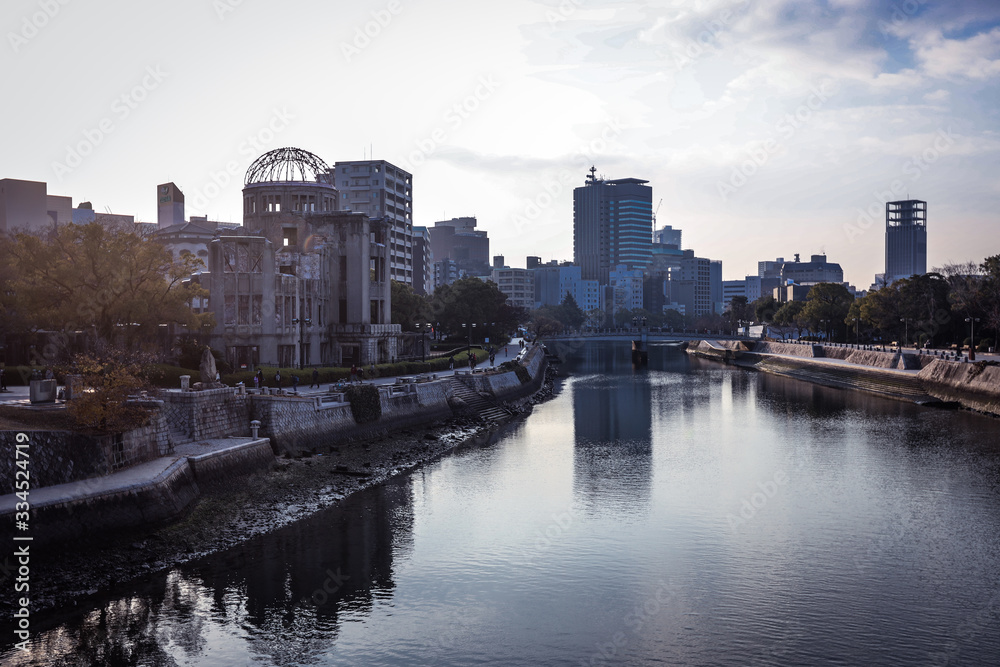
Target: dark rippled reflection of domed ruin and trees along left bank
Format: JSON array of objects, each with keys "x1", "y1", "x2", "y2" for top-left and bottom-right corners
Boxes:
[{"x1": 17, "y1": 477, "x2": 413, "y2": 665}]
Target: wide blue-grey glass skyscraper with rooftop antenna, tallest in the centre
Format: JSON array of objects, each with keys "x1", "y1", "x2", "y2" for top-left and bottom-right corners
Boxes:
[{"x1": 573, "y1": 167, "x2": 653, "y2": 285}]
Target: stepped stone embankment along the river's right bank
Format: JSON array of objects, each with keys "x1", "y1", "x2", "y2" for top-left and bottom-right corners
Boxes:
[{"x1": 687, "y1": 340, "x2": 1000, "y2": 416}]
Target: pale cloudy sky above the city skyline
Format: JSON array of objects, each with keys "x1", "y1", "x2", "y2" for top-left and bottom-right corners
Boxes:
[{"x1": 0, "y1": 0, "x2": 1000, "y2": 289}]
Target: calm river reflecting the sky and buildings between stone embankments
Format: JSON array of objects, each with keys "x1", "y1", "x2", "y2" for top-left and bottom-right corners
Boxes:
[{"x1": 0, "y1": 343, "x2": 1000, "y2": 666}]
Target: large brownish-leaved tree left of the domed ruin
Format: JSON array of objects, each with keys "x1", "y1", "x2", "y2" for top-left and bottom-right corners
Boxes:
[{"x1": 3, "y1": 223, "x2": 212, "y2": 348}]
